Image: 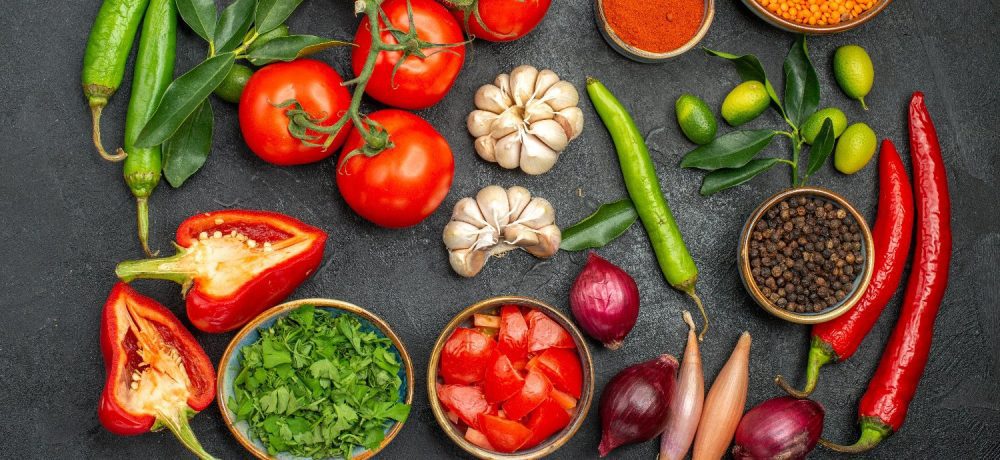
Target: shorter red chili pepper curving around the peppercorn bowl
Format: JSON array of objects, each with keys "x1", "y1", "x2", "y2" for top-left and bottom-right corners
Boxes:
[{"x1": 774, "y1": 139, "x2": 914, "y2": 398}]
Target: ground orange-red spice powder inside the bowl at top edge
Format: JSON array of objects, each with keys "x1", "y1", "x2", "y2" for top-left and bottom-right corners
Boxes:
[{"x1": 603, "y1": 0, "x2": 705, "y2": 53}]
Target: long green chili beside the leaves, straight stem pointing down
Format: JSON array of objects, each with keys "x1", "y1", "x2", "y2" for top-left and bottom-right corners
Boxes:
[{"x1": 123, "y1": 0, "x2": 177, "y2": 255}]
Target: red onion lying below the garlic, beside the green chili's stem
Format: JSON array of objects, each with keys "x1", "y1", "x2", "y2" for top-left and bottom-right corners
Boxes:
[{"x1": 569, "y1": 252, "x2": 639, "y2": 350}]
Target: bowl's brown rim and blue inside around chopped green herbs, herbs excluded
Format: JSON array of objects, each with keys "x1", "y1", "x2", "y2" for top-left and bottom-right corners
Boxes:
[{"x1": 216, "y1": 299, "x2": 413, "y2": 460}]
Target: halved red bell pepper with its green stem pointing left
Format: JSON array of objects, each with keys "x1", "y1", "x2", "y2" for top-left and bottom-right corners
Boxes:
[{"x1": 115, "y1": 210, "x2": 326, "y2": 332}]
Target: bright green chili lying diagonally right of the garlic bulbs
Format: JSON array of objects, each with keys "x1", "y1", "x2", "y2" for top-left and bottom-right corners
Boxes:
[{"x1": 587, "y1": 77, "x2": 708, "y2": 340}]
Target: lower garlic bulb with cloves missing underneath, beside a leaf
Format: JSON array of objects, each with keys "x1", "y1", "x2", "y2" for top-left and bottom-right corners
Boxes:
[{"x1": 443, "y1": 185, "x2": 562, "y2": 278}]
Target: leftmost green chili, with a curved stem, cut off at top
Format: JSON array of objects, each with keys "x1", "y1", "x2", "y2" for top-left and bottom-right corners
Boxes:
[{"x1": 81, "y1": 0, "x2": 149, "y2": 161}]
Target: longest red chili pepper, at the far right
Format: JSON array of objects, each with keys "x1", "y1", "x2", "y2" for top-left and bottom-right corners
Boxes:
[{"x1": 820, "y1": 92, "x2": 951, "y2": 453}]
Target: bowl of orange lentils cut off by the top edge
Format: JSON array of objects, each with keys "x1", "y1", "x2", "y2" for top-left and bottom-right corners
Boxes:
[{"x1": 743, "y1": 0, "x2": 892, "y2": 35}]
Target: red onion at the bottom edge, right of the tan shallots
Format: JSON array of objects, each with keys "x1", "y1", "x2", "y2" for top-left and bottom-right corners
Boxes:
[{"x1": 733, "y1": 396, "x2": 826, "y2": 460}]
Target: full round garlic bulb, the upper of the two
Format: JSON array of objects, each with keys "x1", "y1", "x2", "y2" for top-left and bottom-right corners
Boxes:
[{"x1": 466, "y1": 65, "x2": 583, "y2": 174}]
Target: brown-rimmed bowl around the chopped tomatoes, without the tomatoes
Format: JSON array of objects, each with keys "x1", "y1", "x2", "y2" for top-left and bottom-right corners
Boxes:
[{"x1": 427, "y1": 296, "x2": 594, "y2": 460}]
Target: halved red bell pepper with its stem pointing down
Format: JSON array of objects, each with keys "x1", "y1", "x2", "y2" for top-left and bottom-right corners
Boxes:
[{"x1": 97, "y1": 283, "x2": 215, "y2": 459}]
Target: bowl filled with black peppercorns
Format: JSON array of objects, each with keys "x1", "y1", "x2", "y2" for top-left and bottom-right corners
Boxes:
[{"x1": 737, "y1": 187, "x2": 875, "y2": 324}]
